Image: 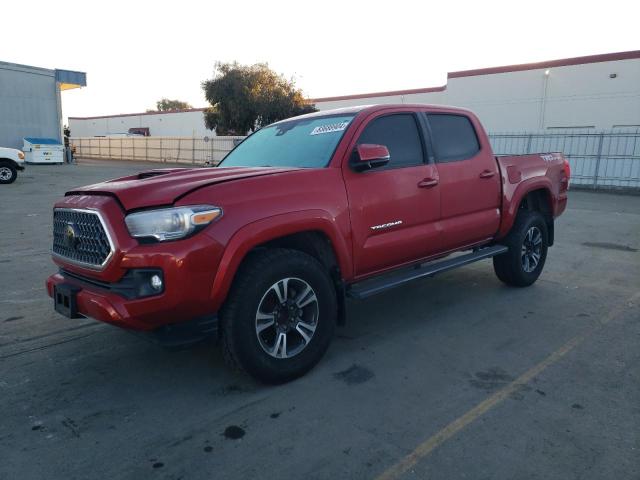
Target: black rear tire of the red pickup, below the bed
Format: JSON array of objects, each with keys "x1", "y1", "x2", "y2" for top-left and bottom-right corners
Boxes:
[{"x1": 493, "y1": 210, "x2": 549, "y2": 287}]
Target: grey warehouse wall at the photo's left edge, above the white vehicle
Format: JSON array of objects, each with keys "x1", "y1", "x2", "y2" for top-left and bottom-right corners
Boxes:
[{"x1": 0, "y1": 62, "x2": 60, "y2": 148}]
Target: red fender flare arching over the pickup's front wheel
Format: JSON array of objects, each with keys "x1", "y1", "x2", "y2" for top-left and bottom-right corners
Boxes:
[{"x1": 211, "y1": 210, "x2": 352, "y2": 311}]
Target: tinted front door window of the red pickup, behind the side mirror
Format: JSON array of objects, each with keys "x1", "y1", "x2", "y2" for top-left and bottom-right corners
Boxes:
[{"x1": 358, "y1": 113, "x2": 424, "y2": 169}]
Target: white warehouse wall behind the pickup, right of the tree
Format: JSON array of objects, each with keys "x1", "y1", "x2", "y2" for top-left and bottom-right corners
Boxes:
[{"x1": 315, "y1": 58, "x2": 640, "y2": 132}]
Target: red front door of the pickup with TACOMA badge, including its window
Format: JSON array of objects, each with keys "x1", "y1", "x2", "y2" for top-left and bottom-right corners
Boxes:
[{"x1": 343, "y1": 109, "x2": 440, "y2": 276}]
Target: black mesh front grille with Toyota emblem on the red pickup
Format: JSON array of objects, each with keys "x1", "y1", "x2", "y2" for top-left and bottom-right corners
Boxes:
[{"x1": 53, "y1": 209, "x2": 111, "y2": 267}]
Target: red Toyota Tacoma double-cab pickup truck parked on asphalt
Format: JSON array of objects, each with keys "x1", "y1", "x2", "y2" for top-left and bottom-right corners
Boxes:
[{"x1": 47, "y1": 105, "x2": 570, "y2": 383}]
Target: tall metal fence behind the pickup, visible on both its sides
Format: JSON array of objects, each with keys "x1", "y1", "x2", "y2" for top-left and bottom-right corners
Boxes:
[{"x1": 71, "y1": 129, "x2": 640, "y2": 190}]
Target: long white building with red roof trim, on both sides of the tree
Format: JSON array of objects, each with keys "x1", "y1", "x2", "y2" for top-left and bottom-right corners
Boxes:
[{"x1": 69, "y1": 50, "x2": 640, "y2": 137}]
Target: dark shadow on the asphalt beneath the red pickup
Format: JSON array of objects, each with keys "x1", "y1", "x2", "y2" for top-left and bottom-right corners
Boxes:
[{"x1": 55, "y1": 265, "x2": 520, "y2": 398}]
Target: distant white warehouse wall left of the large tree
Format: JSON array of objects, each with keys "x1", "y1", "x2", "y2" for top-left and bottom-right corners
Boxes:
[{"x1": 69, "y1": 109, "x2": 215, "y2": 137}]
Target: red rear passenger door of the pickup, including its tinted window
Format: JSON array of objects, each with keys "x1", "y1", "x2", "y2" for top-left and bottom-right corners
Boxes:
[{"x1": 426, "y1": 112, "x2": 501, "y2": 250}]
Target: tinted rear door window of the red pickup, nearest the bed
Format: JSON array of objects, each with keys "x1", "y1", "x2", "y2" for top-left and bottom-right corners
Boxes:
[{"x1": 427, "y1": 113, "x2": 480, "y2": 162}]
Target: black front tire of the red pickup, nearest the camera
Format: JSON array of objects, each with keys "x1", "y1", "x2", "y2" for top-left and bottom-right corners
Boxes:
[{"x1": 221, "y1": 248, "x2": 337, "y2": 384}]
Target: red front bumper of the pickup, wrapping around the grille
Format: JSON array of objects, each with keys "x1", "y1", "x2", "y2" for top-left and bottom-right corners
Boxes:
[{"x1": 46, "y1": 197, "x2": 223, "y2": 331}]
